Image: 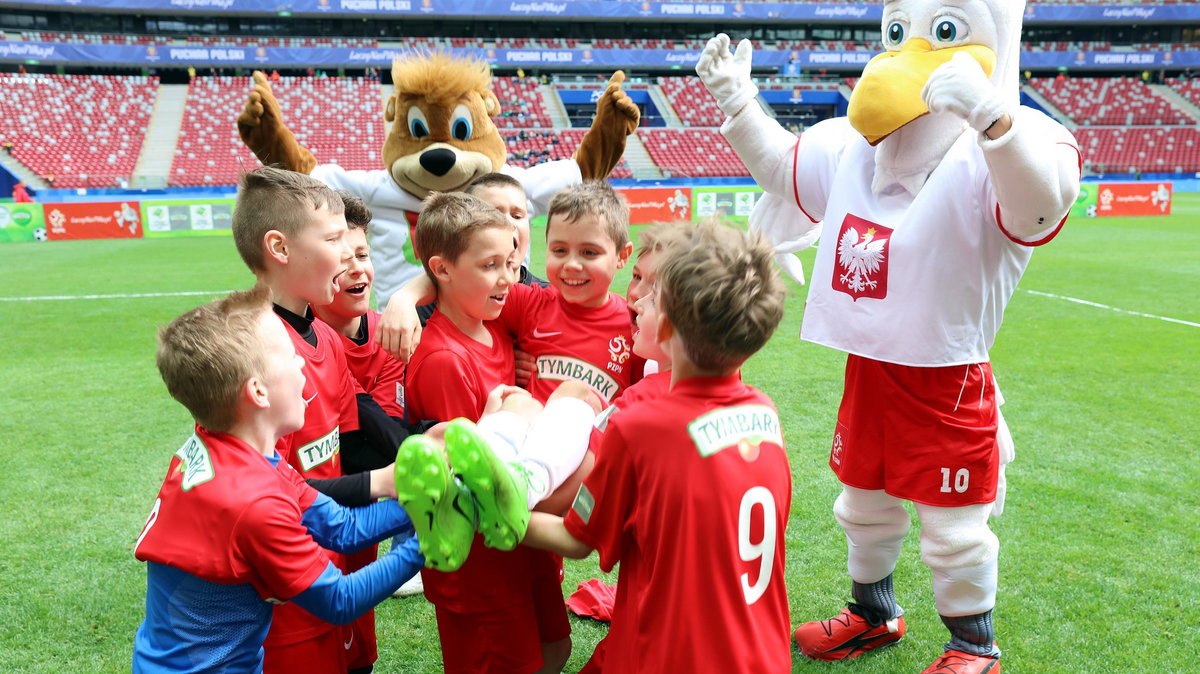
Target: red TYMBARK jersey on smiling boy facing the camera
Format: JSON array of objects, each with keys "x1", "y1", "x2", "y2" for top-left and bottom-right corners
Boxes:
[{"x1": 499, "y1": 284, "x2": 635, "y2": 403}]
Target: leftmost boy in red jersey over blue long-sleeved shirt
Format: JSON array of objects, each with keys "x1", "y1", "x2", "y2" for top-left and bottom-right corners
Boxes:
[{"x1": 133, "y1": 287, "x2": 422, "y2": 673}]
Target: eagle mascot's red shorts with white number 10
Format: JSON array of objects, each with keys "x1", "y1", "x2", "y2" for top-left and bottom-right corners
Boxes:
[{"x1": 829, "y1": 355, "x2": 1000, "y2": 507}]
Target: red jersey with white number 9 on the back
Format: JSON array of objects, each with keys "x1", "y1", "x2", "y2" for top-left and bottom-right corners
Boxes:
[{"x1": 565, "y1": 374, "x2": 792, "y2": 672}]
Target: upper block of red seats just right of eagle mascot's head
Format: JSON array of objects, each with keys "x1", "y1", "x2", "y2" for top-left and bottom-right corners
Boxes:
[{"x1": 1030, "y1": 77, "x2": 1195, "y2": 126}]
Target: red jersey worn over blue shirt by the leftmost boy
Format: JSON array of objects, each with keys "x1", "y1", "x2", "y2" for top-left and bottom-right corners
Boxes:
[{"x1": 133, "y1": 426, "x2": 330, "y2": 601}]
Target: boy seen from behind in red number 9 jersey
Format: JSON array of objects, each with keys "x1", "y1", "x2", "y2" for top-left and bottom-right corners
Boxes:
[{"x1": 523, "y1": 223, "x2": 791, "y2": 673}]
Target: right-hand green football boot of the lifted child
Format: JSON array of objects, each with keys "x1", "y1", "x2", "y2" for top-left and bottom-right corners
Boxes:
[{"x1": 445, "y1": 419, "x2": 529, "y2": 550}]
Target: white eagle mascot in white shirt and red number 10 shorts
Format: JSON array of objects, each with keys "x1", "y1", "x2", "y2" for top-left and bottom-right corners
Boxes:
[{"x1": 696, "y1": 0, "x2": 1081, "y2": 674}]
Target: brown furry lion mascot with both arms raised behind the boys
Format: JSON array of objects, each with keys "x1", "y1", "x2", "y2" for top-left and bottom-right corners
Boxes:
[{"x1": 238, "y1": 53, "x2": 641, "y2": 306}]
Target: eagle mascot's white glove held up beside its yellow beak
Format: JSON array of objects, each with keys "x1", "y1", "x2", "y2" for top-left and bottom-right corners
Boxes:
[{"x1": 921, "y1": 52, "x2": 1010, "y2": 133}]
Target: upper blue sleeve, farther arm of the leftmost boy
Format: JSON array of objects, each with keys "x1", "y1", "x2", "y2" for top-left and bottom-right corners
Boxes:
[{"x1": 300, "y1": 494, "x2": 413, "y2": 553}]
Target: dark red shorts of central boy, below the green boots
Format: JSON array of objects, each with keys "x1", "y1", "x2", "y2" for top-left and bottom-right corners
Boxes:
[{"x1": 434, "y1": 601, "x2": 541, "y2": 674}]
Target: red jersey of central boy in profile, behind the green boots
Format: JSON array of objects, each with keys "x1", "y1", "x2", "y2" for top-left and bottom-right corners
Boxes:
[{"x1": 406, "y1": 312, "x2": 529, "y2": 613}]
